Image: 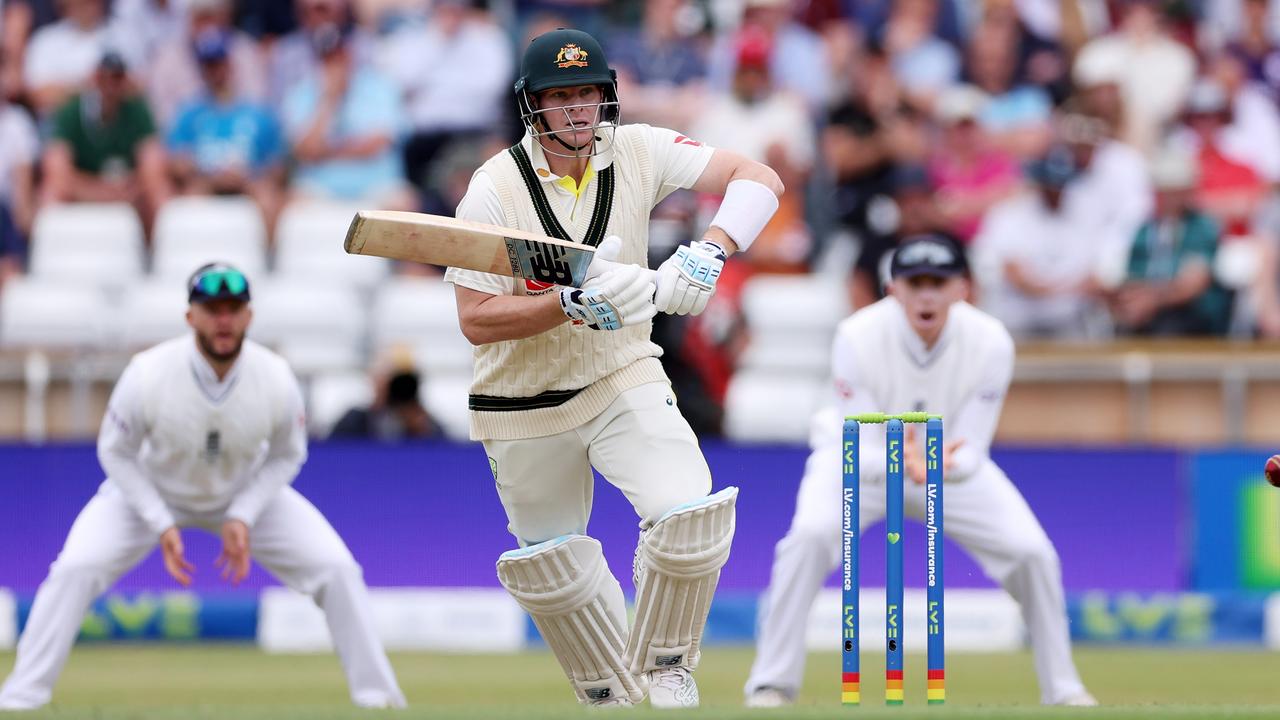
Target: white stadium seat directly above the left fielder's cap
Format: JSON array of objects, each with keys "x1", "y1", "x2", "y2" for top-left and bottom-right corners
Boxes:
[{"x1": 154, "y1": 197, "x2": 266, "y2": 282}]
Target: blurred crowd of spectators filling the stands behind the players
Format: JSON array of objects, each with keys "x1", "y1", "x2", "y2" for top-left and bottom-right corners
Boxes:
[{"x1": 0, "y1": 0, "x2": 1280, "y2": 423}]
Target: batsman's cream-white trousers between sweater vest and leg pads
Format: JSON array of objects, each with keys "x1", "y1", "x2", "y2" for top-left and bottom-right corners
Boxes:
[{"x1": 484, "y1": 383, "x2": 712, "y2": 546}]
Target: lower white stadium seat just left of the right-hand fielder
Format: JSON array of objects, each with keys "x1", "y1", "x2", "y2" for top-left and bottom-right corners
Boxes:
[{"x1": 724, "y1": 370, "x2": 827, "y2": 442}]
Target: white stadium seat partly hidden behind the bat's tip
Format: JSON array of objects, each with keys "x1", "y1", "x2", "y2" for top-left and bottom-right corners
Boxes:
[{"x1": 275, "y1": 202, "x2": 390, "y2": 287}]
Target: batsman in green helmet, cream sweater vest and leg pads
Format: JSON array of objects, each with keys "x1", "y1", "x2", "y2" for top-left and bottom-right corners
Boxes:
[{"x1": 445, "y1": 28, "x2": 782, "y2": 707}]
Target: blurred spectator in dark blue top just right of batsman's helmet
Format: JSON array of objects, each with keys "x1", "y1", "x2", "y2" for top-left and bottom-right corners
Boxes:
[{"x1": 608, "y1": 0, "x2": 707, "y2": 128}]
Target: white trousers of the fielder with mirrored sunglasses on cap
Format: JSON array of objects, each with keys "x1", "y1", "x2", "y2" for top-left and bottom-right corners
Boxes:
[{"x1": 0, "y1": 482, "x2": 404, "y2": 708}]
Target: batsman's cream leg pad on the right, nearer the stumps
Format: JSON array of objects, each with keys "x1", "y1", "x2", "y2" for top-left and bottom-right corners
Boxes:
[{"x1": 626, "y1": 487, "x2": 737, "y2": 674}]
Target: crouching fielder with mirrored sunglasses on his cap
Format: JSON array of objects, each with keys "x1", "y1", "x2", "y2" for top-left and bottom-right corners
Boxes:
[{"x1": 0, "y1": 264, "x2": 404, "y2": 710}]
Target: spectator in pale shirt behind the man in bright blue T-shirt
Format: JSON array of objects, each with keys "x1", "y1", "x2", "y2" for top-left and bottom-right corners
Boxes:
[{"x1": 146, "y1": 0, "x2": 266, "y2": 128}]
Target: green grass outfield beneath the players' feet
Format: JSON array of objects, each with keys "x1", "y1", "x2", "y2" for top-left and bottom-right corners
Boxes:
[{"x1": 0, "y1": 646, "x2": 1280, "y2": 720}]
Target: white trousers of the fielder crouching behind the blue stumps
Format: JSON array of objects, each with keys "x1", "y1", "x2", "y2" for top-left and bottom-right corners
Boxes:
[{"x1": 746, "y1": 441, "x2": 1084, "y2": 703}]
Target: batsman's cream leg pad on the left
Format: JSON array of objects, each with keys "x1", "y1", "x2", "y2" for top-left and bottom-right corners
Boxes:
[{"x1": 498, "y1": 536, "x2": 644, "y2": 703}]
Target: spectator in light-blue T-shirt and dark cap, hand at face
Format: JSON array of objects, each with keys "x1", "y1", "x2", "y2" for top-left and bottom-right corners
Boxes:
[{"x1": 284, "y1": 24, "x2": 417, "y2": 210}]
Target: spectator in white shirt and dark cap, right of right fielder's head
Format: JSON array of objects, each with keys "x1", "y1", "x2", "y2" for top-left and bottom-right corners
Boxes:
[{"x1": 973, "y1": 146, "x2": 1107, "y2": 340}]
